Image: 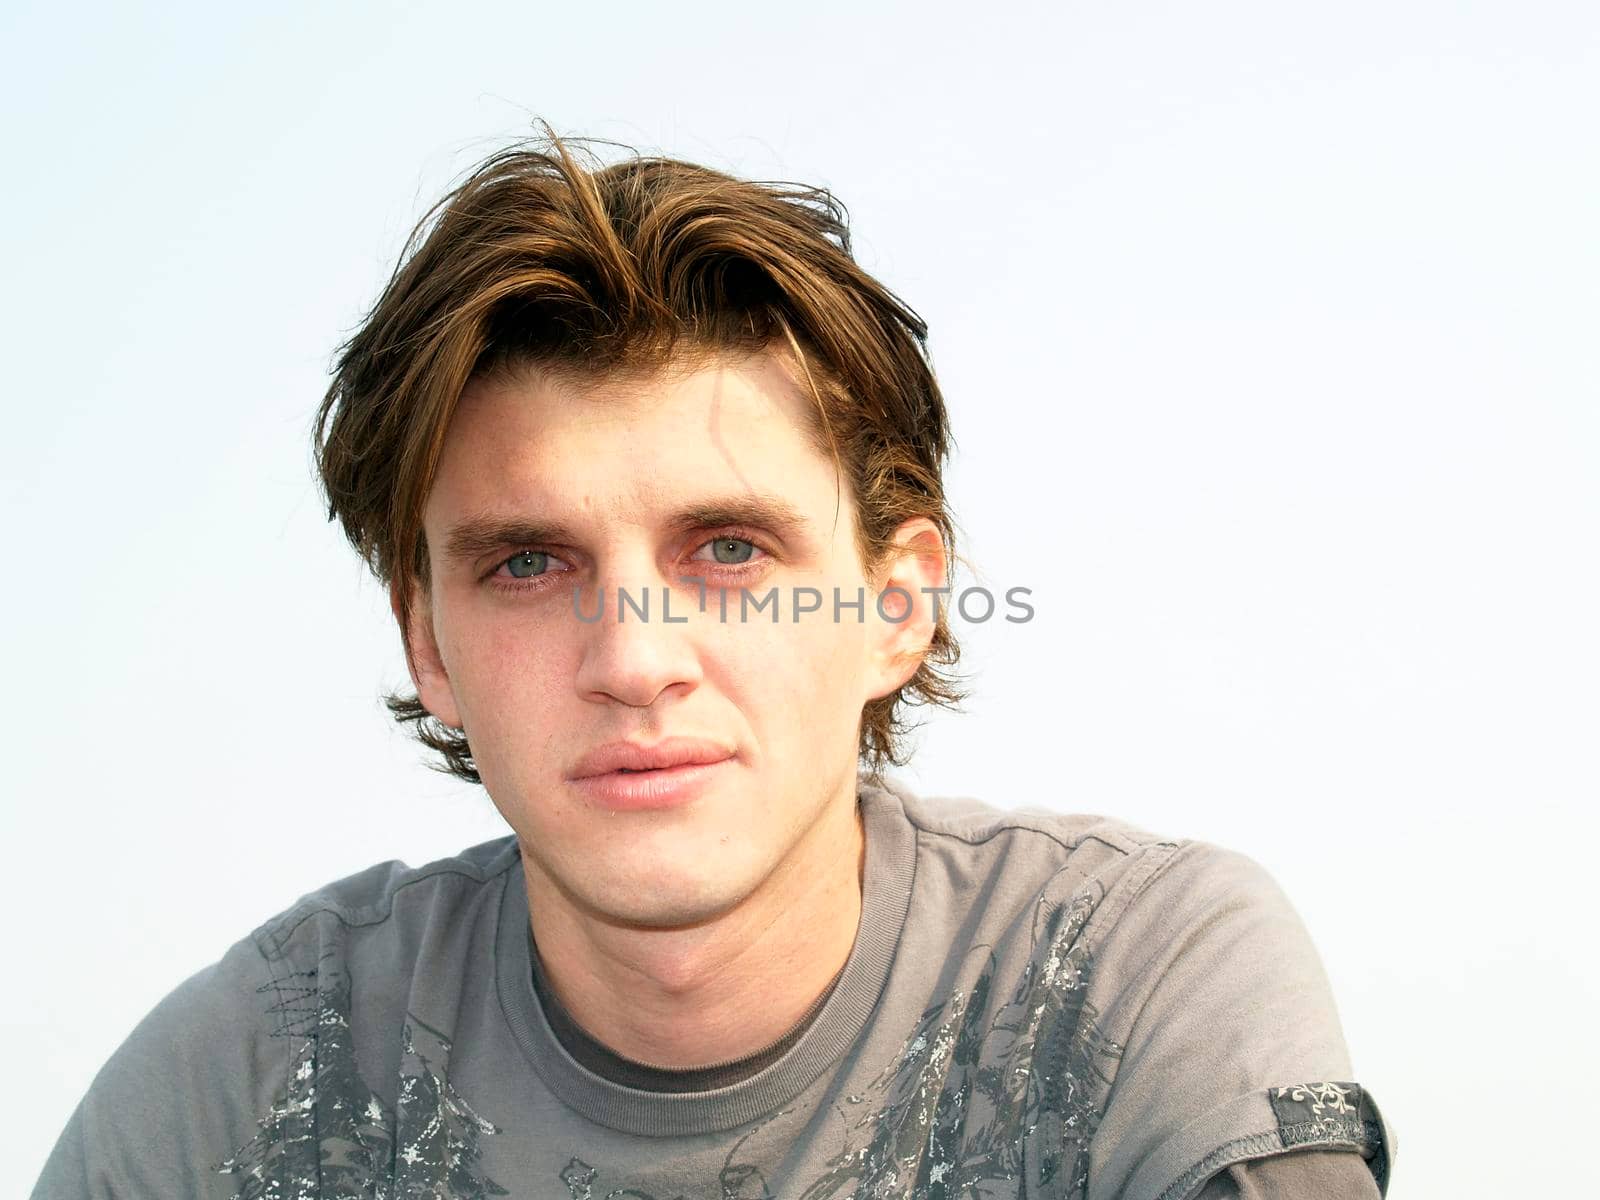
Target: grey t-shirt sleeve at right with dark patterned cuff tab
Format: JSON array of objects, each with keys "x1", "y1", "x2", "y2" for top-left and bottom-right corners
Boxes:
[{"x1": 1088, "y1": 842, "x2": 1395, "y2": 1200}]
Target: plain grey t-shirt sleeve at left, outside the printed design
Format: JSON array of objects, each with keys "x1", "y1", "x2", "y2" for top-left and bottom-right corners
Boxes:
[{"x1": 32, "y1": 939, "x2": 296, "y2": 1200}]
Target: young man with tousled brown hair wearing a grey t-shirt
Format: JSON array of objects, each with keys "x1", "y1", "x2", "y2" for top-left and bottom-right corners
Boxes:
[{"x1": 35, "y1": 131, "x2": 1394, "y2": 1200}]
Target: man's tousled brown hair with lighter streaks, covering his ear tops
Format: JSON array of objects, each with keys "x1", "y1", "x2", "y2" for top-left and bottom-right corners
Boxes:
[{"x1": 315, "y1": 125, "x2": 965, "y2": 782}]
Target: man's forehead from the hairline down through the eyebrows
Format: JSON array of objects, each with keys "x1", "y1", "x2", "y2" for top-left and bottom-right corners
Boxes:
[{"x1": 427, "y1": 342, "x2": 842, "y2": 562}]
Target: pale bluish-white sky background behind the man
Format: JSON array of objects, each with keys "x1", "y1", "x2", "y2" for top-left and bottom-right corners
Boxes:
[{"x1": 0, "y1": 0, "x2": 1600, "y2": 1200}]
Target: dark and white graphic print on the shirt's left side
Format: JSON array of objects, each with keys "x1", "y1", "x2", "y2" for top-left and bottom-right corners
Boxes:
[{"x1": 216, "y1": 971, "x2": 507, "y2": 1200}]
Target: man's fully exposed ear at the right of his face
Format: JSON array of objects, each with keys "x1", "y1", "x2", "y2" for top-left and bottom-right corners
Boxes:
[{"x1": 862, "y1": 517, "x2": 947, "y2": 701}]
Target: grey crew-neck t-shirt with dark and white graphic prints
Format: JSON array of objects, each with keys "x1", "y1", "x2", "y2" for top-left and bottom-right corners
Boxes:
[{"x1": 34, "y1": 781, "x2": 1395, "y2": 1200}]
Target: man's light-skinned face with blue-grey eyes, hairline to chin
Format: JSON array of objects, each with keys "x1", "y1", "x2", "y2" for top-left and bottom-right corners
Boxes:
[{"x1": 400, "y1": 347, "x2": 944, "y2": 926}]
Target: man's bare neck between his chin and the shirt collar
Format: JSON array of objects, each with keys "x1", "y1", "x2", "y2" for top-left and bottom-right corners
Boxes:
[{"x1": 523, "y1": 803, "x2": 866, "y2": 1069}]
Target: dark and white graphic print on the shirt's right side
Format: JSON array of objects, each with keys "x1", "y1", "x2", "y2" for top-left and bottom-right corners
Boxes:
[{"x1": 560, "y1": 885, "x2": 1123, "y2": 1200}]
